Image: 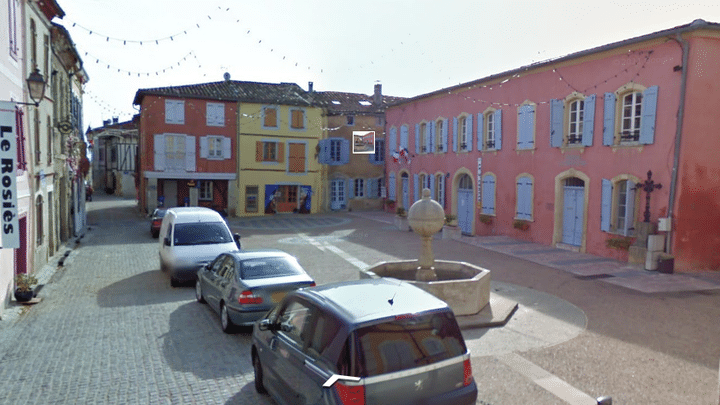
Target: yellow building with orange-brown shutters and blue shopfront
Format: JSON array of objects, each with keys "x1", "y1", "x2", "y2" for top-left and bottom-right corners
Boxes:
[{"x1": 235, "y1": 82, "x2": 326, "y2": 216}]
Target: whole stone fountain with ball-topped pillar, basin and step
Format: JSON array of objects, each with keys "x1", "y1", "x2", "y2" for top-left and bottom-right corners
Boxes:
[{"x1": 360, "y1": 188, "x2": 517, "y2": 326}]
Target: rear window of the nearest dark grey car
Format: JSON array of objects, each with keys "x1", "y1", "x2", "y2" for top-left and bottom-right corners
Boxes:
[{"x1": 356, "y1": 311, "x2": 467, "y2": 377}]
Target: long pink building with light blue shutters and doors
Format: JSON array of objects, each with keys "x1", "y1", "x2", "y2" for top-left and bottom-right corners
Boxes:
[{"x1": 386, "y1": 20, "x2": 720, "y2": 271}]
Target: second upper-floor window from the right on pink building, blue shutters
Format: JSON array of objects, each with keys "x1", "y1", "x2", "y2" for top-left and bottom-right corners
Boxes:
[{"x1": 550, "y1": 93, "x2": 595, "y2": 148}]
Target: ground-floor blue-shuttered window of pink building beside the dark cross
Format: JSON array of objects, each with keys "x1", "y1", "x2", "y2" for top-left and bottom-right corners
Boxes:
[{"x1": 600, "y1": 175, "x2": 637, "y2": 236}]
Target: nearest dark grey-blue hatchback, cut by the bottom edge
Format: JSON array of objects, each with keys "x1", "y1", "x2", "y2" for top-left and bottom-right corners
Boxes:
[{"x1": 251, "y1": 278, "x2": 477, "y2": 405}]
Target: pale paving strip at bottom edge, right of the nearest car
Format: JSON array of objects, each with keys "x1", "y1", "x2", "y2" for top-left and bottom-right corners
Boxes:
[{"x1": 495, "y1": 353, "x2": 597, "y2": 405}]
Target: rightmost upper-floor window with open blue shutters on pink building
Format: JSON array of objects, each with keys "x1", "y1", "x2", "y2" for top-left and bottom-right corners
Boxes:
[{"x1": 603, "y1": 83, "x2": 658, "y2": 146}]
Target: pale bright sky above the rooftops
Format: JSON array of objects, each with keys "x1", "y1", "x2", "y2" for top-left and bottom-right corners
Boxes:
[{"x1": 55, "y1": 0, "x2": 720, "y2": 128}]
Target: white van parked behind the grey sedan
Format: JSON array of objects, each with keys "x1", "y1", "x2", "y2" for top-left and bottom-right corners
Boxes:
[{"x1": 159, "y1": 207, "x2": 240, "y2": 287}]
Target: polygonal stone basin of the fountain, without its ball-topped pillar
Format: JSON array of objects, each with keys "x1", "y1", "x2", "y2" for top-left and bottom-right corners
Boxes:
[{"x1": 360, "y1": 260, "x2": 490, "y2": 316}]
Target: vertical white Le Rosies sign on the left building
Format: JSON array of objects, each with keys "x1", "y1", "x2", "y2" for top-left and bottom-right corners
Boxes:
[{"x1": 0, "y1": 101, "x2": 20, "y2": 249}]
